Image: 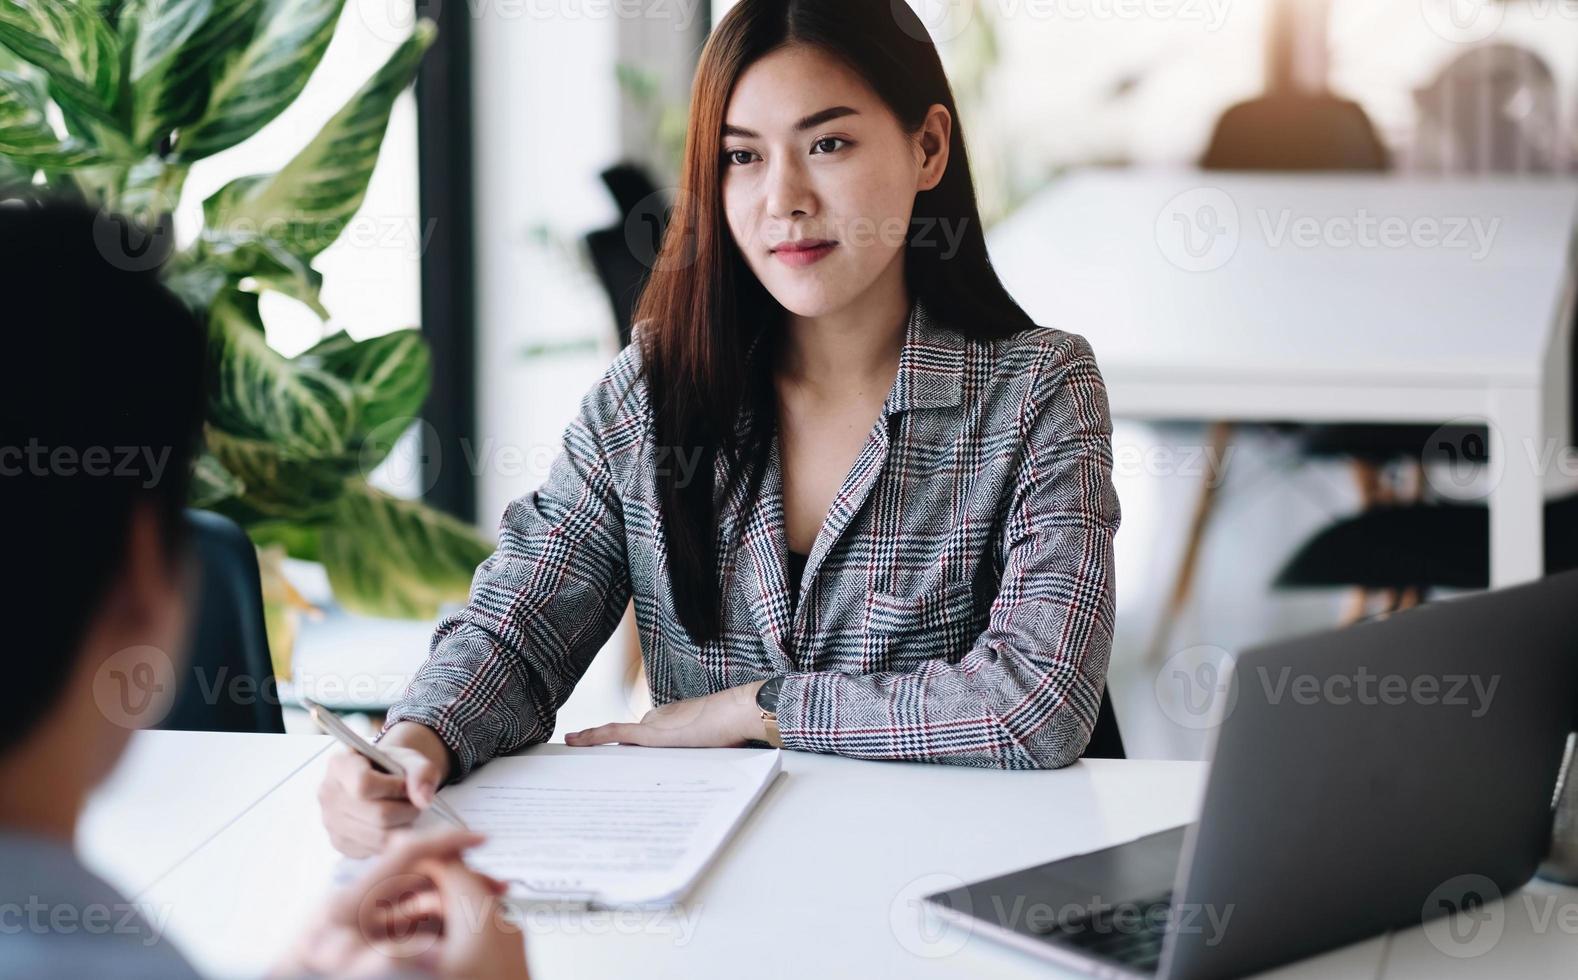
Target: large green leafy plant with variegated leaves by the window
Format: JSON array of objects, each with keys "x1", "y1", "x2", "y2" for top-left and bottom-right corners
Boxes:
[{"x1": 0, "y1": 0, "x2": 489, "y2": 637}]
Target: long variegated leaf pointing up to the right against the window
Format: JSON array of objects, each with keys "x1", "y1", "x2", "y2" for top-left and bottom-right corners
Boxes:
[{"x1": 204, "y1": 21, "x2": 434, "y2": 257}]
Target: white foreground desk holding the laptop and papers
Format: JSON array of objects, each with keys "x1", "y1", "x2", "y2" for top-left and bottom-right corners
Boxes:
[{"x1": 82, "y1": 732, "x2": 1578, "y2": 980}]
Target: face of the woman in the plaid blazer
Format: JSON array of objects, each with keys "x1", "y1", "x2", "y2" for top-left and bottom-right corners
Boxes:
[{"x1": 720, "y1": 44, "x2": 952, "y2": 317}]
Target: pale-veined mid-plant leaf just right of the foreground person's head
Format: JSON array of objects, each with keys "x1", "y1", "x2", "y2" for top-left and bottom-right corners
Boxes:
[{"x1": 208, "y1": 292, "x2": 355, "y2": 457}]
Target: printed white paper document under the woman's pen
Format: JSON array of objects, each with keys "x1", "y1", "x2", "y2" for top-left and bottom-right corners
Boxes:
[{"x1": 397, "y1": 745, "x2": 781, "y2": 907}]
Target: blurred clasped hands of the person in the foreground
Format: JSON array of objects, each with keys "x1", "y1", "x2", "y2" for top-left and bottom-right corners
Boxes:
[{"x1": 273, "y1": 832, "x2": 527, "y2": 980}]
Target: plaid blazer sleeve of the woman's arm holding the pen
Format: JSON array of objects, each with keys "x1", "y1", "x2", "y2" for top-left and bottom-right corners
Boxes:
[{"x1": 385, "y1": 344, "x2": 639, "y2": 778}]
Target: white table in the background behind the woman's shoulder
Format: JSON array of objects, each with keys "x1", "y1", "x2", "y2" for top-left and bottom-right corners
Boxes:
[{"x1": 989, "y1": 169, "x2": 1578, "y2": 585}]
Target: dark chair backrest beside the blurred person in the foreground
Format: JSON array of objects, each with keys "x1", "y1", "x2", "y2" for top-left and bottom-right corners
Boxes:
[{"x1": 159, "y1": 510, "x2": 286, "y2": 734}]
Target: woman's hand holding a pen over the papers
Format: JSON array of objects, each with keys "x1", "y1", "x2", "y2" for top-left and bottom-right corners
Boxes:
[{"x1": 317, "y1": 721, "x2": 450, "y2": 857}]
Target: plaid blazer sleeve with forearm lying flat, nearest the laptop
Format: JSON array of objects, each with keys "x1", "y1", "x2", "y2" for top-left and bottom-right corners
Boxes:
[{"x1": 766, "y1": 335, "x2": 1119, "y2": 769}]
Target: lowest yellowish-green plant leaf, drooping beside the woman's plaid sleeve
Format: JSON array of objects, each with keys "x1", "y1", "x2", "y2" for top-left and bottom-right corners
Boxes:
[{"x1": 319, "y1": 483, "x2": 491, "y2": 619}]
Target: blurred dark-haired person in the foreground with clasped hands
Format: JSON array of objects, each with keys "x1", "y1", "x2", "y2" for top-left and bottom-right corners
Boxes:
[{"x1": 0, "y1": 202, "x2": 525, "y2": 980}]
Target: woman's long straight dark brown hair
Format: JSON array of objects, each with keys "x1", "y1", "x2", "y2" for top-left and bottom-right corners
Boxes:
[{"x1": 633, "y1": 0, "x2": 1032, "y2": 644}]
